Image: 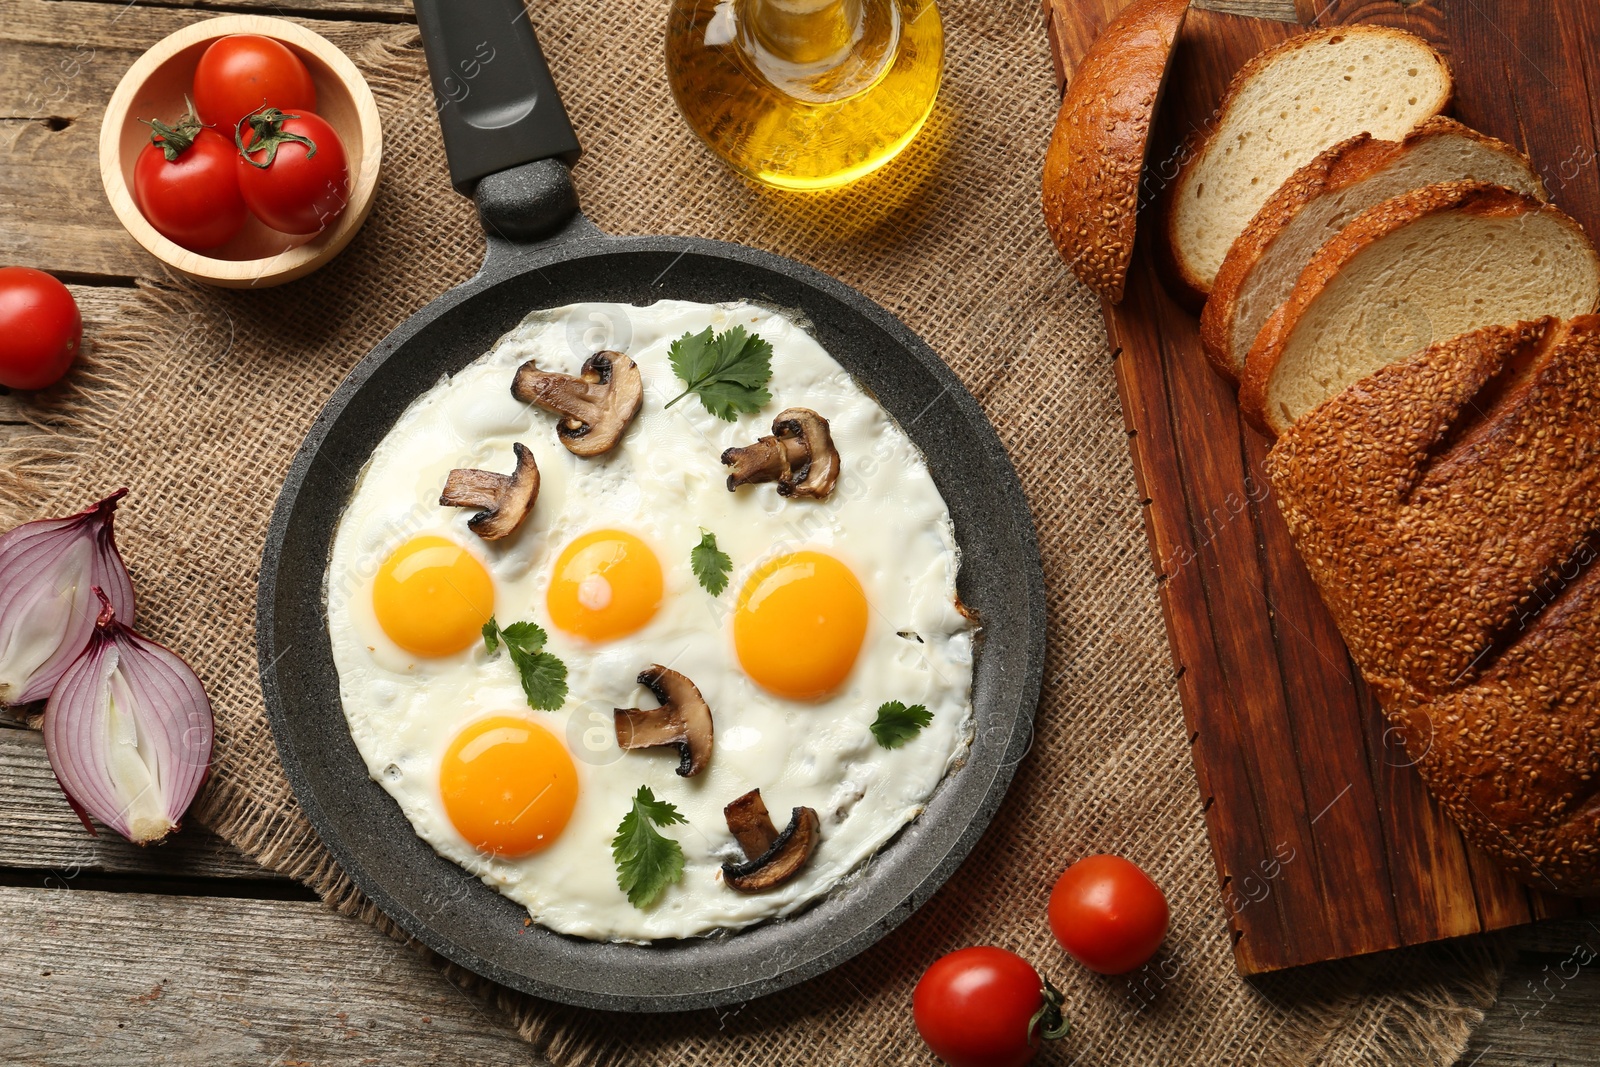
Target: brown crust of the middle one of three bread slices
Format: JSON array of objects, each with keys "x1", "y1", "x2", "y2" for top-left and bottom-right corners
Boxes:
[{"x1": 1200, "y1": 115, "x2": 1549, "y2": 384}]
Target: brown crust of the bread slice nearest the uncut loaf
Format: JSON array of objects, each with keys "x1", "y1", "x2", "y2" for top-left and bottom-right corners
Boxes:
[{"x1": 1238, "y1": 181, "x2": 1600, "y2": 435}]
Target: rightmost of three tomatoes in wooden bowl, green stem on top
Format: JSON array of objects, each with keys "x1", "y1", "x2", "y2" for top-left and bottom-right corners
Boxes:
[{"x1": 237, "y1": 107, "x2": 350, "y2": 234}]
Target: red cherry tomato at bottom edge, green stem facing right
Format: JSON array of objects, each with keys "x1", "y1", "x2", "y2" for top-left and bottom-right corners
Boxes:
[{"x1": 912, "y1": 945, "x2": 1067, "y2": 1067}]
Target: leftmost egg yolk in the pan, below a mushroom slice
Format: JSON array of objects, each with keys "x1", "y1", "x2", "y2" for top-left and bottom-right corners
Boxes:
[{"x1": 373, "y1": 536, "x2": 494, "y2": 656}]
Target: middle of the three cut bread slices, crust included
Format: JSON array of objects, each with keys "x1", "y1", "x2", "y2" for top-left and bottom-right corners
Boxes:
[{"x1": 1200, "y1": 115, "x2": 1549, "y2": 381}]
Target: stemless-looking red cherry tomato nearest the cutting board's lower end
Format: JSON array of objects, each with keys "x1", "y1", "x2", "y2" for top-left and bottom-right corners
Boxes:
[{"x1": 1050, "y1": 856, "x2": 1171, "y2": 974}]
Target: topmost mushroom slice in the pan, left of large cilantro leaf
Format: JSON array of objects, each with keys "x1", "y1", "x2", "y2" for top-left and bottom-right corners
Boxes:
[{"x1": 510, "y1": 352, "x2": 645, "y2": 456}]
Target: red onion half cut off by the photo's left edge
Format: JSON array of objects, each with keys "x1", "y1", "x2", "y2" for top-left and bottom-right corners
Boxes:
[{"x1": 0, "y1": 490, "x2": 133, "y2": 704}]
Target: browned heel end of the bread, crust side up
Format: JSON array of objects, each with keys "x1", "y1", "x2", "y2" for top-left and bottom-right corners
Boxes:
[{"x1": 1043, "y1": 0, "x2": 1189, "y2": 304}]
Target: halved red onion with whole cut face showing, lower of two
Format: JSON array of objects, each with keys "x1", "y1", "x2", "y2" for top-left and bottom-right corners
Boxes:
[{"x1": 45, "y1": 589, "x2": 214, "y2": 845}]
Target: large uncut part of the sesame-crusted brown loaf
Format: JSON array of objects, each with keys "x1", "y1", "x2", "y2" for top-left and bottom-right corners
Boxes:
[{"x1": 1266, "y1": 315, "x2": 1600, "y2": 894}]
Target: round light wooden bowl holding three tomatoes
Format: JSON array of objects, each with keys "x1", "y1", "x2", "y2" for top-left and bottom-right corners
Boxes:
[{"x1": 99, "y1": 14, "x2": 382, "y2": 288}]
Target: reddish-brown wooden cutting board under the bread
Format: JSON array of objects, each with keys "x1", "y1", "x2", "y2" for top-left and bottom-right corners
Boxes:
[{"x1": 1045, "y1": 0, "x2": 1600, "y2": 974}]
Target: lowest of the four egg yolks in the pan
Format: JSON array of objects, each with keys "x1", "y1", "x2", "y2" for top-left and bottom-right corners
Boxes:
[{"x1": 438, "y1": 715, "x2": 578, "y2": 856}]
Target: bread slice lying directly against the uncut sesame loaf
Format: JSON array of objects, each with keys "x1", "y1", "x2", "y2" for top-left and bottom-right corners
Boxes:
[{"x1": 1238, "y1": 182, "x2": 1600, "y2": 434}]
